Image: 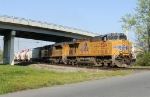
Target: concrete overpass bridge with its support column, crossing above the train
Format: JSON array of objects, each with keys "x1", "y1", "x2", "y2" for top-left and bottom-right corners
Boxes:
[{"x1": 0, "y1": 16, "x2": 98, "y2": 65}]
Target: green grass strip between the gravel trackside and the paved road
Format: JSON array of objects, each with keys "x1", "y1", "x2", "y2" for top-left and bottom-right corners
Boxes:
[{"x1": 0, "y1": 65, "x2": 133, "y2": 94}]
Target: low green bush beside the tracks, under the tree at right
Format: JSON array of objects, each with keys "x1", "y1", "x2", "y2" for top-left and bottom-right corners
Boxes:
[{"x1": 135, "y1": 52, "x2": 150, "y2": 66}]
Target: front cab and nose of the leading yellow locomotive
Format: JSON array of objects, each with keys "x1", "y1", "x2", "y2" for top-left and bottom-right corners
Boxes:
[{"x1": 103, "y1": 33, "x2": 132, "y2": 67}]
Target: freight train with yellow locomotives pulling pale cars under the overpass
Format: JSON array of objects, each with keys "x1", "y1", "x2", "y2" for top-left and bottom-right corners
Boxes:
[{"x1": 14, "y1": 33, "x2": 132, "y2": 67}]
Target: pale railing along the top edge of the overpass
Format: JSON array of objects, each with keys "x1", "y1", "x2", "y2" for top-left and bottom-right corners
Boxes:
[{"x1": 0, "y1": 15, "x2": 98, "y2": 36}]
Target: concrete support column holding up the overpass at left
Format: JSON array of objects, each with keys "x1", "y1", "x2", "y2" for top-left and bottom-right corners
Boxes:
[{"x1": 3, "y1": 31, "x2": 16, "y2": 65}]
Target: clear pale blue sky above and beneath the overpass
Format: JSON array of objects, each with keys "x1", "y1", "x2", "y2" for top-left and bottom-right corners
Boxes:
[{"x1": 0, "y1": 0, "x2": 137, "y2": 52}]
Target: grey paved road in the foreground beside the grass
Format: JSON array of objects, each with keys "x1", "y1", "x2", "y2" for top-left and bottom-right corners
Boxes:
[{"x1": 0, "y1": 71, "x2": 150, "y2": 97}]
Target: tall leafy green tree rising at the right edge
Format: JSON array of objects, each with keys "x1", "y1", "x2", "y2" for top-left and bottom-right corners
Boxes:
[{"x1": 121, "y1": 0, "x2": 150, "y2": 53}]
